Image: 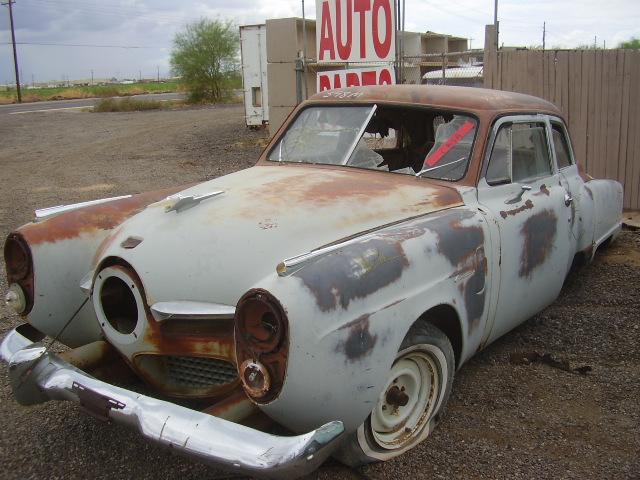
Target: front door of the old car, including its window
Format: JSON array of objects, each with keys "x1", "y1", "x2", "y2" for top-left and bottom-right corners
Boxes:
[{"x1": 478, "y1": 115, "x2": 573, "y2": 342}]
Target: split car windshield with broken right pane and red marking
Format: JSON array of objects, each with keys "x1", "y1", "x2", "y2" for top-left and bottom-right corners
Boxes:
[{"x1": 268, "y1": 105, "x2": 477, "y2": 181}]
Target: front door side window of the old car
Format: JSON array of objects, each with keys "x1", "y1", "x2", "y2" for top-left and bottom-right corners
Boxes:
[{"x1": 486, "y1": 122, "x2": 552, "y2": 185}]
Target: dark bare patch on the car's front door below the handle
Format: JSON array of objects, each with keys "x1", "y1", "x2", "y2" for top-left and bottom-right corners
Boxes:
[{"x1": 518, "y1": 210, "x2": 558, "y2": 277}]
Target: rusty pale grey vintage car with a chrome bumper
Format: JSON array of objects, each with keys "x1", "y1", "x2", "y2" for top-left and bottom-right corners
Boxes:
[{"x1": 0, "y1": 86, "x2": 622, "y2": 477}]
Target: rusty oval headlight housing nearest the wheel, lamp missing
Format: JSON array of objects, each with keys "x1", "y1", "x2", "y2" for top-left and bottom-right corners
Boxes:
[{"x1": 235, "y1": 289, "x2": 289, "y2": 404}]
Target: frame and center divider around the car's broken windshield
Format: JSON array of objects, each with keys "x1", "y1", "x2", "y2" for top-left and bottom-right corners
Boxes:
[{"x1": 258, "y1": 100, "x2": 482, "y2": 184}]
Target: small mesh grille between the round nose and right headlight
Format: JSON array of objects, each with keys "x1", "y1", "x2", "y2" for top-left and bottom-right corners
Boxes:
[{"x1": 164, "y1": 356, "x2": 237, "y2": 388}]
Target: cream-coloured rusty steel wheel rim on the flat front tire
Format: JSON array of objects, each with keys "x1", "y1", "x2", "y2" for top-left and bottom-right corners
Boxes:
[{"x1": 370, "y1": 350, "x2": 442, "y2": 450}]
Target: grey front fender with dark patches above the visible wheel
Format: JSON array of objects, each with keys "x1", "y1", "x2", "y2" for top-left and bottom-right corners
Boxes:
[{"x1": 259, "y1": 208, "x2": 488, "y2": 432}]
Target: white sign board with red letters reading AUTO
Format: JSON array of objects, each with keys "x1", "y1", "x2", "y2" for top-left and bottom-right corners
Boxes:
[{"x1": 316, "y1": 0, "x2": 396, "y2": 63}]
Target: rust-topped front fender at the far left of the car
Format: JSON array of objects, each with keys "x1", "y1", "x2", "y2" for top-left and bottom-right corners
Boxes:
[{"x1": 5, "y1": 187, "x2": 191, "y2": 347}]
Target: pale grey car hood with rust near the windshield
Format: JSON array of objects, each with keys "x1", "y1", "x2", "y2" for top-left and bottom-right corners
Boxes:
[{"x1": 95, "y1": 164, "x2": 463, "y2": 305}]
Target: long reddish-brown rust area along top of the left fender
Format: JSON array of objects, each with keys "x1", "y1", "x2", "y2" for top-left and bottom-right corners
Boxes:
[{"x1": 18, "y1": 185, "x2": 193, "y2": 245}]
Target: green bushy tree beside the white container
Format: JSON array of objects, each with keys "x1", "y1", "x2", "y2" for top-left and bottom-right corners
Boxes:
[{"x1": 171, "y1": 19, "x2": 239, "y2": 102}]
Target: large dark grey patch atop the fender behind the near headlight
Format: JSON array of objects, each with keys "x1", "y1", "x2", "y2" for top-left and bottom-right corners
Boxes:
[{"x1": 293, "y1": 235, "x2": 409, "y2": 312}]
